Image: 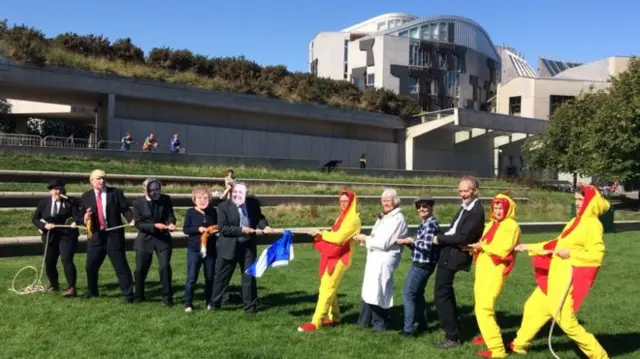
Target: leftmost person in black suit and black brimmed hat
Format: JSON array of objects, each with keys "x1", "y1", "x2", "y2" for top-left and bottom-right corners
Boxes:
[{"x1": 31, "y1": 179, "x2": 82, "y2": 297}]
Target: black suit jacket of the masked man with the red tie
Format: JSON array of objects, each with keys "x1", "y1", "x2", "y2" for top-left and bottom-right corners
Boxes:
[{"x1": 80, "y1": 187, "x2": 133, "y2": 247}]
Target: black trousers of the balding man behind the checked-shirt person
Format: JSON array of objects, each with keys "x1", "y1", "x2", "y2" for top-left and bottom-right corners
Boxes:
[{"x1": 434, "y1": 265, "x2": 460, "y2": 341}]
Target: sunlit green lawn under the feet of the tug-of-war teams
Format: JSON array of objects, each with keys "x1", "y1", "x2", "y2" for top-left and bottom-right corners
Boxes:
[{"x1": 0, "y1": 233, "x2": 640, "y2": 359}]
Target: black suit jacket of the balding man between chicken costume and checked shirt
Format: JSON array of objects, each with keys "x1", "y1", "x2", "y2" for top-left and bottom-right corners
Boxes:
[{"x1": 438, "y1": 200, "x2": 484, "y2": 272}]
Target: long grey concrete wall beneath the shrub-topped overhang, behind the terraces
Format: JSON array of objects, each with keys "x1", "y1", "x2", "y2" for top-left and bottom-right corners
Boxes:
[{"x1": 109, "y1": 118, "x2": 398, "y2": 169}]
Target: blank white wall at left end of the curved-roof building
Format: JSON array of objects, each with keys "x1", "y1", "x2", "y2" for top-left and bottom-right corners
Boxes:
[{"x1": 309, "y1": 32, "x2": 349, "y2": 80}]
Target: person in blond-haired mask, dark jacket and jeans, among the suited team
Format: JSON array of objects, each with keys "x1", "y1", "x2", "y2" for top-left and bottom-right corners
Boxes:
[{"x1": 182, "y1": 187, "x2": 218, "y2": 313}]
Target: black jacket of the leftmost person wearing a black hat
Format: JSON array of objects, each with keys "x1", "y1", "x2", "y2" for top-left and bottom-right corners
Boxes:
[{"x1": 31, "y1": 197, "x2": 82, "y2": 241}]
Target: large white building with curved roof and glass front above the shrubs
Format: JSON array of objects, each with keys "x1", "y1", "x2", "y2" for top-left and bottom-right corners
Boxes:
[{"x1": 309, "y1": 13, "x2": 501, "y2": 112}]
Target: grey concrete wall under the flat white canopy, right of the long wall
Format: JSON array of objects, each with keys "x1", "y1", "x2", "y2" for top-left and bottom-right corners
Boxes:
[{"x1": 413, "y1": 129, "x2": 493, "y2": 177}]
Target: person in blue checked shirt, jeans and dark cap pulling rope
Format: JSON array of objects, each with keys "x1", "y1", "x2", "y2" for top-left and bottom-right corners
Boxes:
[{"x1": 396, "y1": 198, "x2": 440, "y2": 336}]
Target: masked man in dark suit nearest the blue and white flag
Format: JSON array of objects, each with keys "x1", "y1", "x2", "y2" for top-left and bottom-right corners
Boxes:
[{"x1": 211, "y1": 183, "x2": 271, "y2": 314}]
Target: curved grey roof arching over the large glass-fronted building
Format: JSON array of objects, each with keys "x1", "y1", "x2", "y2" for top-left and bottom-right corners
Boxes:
[{"x1": 374, "y1": 15, "x2": 500, "y2": 62}]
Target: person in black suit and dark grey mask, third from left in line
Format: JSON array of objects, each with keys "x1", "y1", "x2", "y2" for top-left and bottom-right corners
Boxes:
[{"x1": 133, "y1": 178, "x2": 176, "y2": 307}]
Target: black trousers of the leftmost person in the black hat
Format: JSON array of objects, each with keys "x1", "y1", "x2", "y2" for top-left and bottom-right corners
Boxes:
[{"x1": 44, "y1": 234, "x2": 78, "y2": 288}]
